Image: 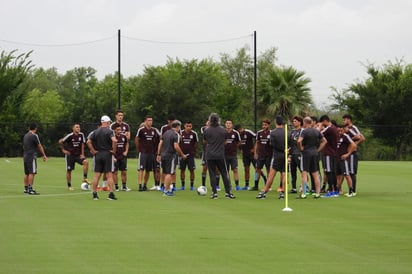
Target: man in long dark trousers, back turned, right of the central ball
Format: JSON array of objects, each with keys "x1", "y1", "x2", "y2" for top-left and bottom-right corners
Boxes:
[{"x1": 203, "y1": 113, "x2": 236, "y2": 199}]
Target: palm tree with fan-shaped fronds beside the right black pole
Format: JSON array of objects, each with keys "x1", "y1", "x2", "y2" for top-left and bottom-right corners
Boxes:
[{"x1": 258, "y1": 66, "x2": 312, "y2": 119}]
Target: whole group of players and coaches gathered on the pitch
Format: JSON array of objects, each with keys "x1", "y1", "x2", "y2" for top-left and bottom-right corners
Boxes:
[{"x1": 24, "y1": 110, "x2": 364, "y2": 200}]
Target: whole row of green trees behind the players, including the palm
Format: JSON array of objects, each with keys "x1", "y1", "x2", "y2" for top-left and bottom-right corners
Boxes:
[{"x1": 0, "y1": 48, "x2": 412, "y2": 159}]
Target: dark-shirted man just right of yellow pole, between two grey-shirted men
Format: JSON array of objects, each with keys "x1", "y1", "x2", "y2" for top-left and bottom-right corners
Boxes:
[{"x1": 289, "y1": 115, "x2": 303, "y2": 193}]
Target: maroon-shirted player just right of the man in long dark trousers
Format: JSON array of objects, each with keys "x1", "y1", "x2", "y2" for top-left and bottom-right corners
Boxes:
[{"x1": 225, "y1": 119, "x2": 240, "y2": 190}]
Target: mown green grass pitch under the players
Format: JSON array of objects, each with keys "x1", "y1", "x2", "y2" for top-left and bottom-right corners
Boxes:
[{"x1": 0, "y1": 158, "x2": 412, "y2": 274}]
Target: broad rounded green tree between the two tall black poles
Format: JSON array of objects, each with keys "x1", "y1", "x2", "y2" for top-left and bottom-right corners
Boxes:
[{"x1": 134, "y1": 58, "x2": 228, "y2": 124}]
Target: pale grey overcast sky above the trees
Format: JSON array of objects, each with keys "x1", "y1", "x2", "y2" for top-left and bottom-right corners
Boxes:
[{"x1": 0, "y1": 0, "x2": 412, "y2": 105}]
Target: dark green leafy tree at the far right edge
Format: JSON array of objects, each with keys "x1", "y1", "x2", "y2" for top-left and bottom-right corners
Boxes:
[{"x1": 332, "y1": 61, "x2": 412, "y2": 160}]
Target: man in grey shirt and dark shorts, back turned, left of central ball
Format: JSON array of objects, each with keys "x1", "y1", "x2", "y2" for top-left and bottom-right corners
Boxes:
[{"x1": 157, "y1": 120, "x2": 187, "y2": 196}]
